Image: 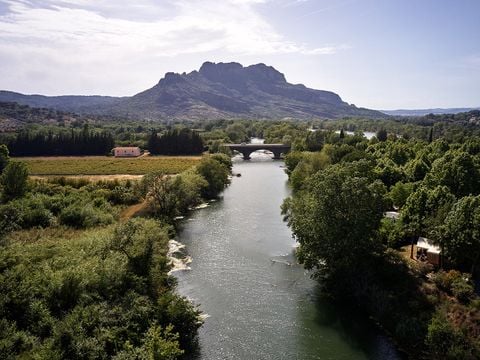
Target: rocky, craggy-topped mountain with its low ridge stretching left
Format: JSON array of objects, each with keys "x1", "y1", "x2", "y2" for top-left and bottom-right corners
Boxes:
[{"x1": 0, "y1": 62, "x2": 385, "y2": 120}]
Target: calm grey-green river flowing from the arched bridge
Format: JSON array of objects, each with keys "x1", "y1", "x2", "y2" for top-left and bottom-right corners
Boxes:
[{"x1": 175, "y1": 154, "x2": 400, "y2": 360}]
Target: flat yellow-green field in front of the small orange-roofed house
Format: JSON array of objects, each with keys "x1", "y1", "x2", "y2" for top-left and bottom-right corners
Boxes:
[{"x1": 15, "y1": 156, "x2": 201, "y2": 175}]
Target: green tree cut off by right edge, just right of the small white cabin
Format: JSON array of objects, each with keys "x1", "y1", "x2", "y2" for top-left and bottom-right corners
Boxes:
[{"x1": 439, "y1": 195, "x2": 480, "y2": 274}]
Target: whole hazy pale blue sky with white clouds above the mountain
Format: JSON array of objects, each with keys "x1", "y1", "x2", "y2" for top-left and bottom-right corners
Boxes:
[{"x1": 0, "y1": 0, "x2": 480, "y2": 109}]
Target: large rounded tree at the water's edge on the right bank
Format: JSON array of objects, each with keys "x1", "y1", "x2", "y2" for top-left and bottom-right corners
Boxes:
[{"x1": 282, "y1": 165, "x2": 383, "y2": 272}]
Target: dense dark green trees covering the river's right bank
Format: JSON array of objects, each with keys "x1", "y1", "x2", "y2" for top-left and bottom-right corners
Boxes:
[{"x1": 283, "y1": 131, "x2": 480, "y2": 360}]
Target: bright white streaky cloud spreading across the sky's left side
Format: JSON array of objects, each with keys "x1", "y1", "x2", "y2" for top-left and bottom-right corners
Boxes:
[{"x1": 0, "y1": 0, "x2": 342, "y2": 95}]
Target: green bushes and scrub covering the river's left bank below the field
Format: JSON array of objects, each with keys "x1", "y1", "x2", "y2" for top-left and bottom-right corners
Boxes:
[{"x1": 0, "y1": 146, "x2": 230, "y2": 359}]
